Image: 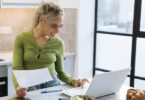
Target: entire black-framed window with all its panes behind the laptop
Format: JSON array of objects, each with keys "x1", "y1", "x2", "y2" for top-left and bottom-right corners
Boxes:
[{"x1": 93, "y1": 0, "x2": 145, "y2": 89}]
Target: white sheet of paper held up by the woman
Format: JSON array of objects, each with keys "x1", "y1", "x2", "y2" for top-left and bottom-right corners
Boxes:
[{"x1": 13, "y1": 67, "x2": 53, "y2": 88}]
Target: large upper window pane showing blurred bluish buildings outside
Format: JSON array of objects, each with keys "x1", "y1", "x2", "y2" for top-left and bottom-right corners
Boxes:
[{"x1": 97, "y1": 0, "x2": 134, "y2": 34}]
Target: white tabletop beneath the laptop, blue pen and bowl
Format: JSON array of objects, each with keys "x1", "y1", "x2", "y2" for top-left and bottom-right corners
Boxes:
[{"x1": 0, "y1": 85, "x2": 129, "y2": 100}]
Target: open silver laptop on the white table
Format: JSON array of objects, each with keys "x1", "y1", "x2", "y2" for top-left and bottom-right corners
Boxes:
[{"x1": 62, "y1": 68, "x2": 130, "y2": 97}]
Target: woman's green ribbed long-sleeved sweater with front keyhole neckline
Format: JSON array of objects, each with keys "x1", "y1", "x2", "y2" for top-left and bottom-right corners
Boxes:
[{"x1": 12, "y1": 30, "x2": 75, "y2": 88}]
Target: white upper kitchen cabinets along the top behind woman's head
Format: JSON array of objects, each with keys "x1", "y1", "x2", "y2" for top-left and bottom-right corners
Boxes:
[{"x1": 0, "y1": 0, "x2": 79, "y2": 8}]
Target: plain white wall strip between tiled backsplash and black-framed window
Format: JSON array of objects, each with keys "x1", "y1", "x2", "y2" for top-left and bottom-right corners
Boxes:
[{"x1": 75, "y1": 0, "x2": 95, "y2": 78}]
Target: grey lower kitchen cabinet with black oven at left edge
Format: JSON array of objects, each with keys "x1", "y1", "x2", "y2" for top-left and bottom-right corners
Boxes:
[{"x1": 0, "y1": 61, "x2": 15, "y2": 97}]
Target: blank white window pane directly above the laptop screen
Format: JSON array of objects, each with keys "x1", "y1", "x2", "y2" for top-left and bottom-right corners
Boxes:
[{"x1": 96, "y1": 33, "x2": 132, "y2": 70}]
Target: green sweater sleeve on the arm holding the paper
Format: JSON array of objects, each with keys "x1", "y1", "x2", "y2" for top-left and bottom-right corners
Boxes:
[{"x1": 12, "y1": 34, "x2": 24, "y2": 89}]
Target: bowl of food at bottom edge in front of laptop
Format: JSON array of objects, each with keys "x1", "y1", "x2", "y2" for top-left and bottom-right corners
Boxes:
[{"x1": 70, "y1": 95, "x2": 96, "y2": 100}]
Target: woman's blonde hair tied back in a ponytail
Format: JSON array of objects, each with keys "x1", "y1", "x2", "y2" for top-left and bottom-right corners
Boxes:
[{"x1": 32, "y1": 2, "x2": 64, "y2": 29}]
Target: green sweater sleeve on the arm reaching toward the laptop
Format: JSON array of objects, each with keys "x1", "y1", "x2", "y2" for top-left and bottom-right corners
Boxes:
[{"x1": 55, "y1": 41, "x2": 75, "y2": 86}]
